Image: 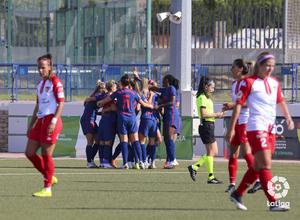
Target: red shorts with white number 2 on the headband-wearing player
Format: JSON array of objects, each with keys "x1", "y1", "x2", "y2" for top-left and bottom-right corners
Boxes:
[{"x1": 247, "y1": 131, "x2": 276, "y2": 154}]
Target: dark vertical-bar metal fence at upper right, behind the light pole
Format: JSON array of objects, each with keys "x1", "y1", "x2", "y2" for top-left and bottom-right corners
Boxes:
[{"x1": 152, "y1": 0, "x2": 284, "y2": 48}]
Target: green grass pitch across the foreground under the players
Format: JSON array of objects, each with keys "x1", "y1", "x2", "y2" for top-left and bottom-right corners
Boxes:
[{"x1": 0, "y1": 159, "x2": 300, "y2": 220}]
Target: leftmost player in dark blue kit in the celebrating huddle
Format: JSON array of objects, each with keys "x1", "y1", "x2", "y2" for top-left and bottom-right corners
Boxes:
[{"x1": 80, "y1": 81, "x2": 105, "y2": 168}]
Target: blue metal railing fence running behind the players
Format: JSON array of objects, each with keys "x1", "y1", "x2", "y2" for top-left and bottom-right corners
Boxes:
[{"x1": 0, "y1": 64, "x2": 300, "y2": 102}]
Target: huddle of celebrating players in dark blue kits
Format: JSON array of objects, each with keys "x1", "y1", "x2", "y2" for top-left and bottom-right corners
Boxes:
[{"x1": 80, "y1": 72, "x2": 180, "y2": 169}]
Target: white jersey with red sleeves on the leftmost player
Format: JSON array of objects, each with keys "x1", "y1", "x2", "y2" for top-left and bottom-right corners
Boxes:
[{"x1": 37, "y1": 74, "x2": 65, "y2": 118}]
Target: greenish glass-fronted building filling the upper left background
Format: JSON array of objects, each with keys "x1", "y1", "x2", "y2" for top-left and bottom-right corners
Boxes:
[{"x1": 0, "y1": 0, "x2": 146, "y2": 64}]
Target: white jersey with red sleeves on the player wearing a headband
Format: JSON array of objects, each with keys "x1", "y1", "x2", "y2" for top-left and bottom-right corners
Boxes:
[{"x1": 236, "y1": 75, "x2": 284, "y2": 133}]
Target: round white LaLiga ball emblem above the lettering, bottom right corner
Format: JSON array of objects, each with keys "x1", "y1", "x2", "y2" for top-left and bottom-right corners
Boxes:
[{"x1": 268, "y1": 176, "x2": 290, "y2": 199}]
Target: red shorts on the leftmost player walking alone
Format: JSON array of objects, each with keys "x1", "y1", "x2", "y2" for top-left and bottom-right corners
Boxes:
[{"x1": 28, "y1": 115, "x2": 63, "y2": 144}]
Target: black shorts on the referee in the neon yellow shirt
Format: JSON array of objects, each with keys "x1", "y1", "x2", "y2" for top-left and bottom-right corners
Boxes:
[{"x1": 198, "y1": 121, "x2": 216, "y2": 144}]
